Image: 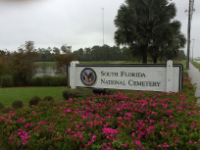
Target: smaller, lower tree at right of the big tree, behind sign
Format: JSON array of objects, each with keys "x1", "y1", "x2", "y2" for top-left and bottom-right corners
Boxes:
[{"x1": 148, "y1": 20, "x2": 186, "y2": 63}]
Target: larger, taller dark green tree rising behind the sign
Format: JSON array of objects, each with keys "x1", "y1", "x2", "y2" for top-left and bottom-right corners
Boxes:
[{"x1": 114, "y1": 0, "x2": 176, "y2": 63}]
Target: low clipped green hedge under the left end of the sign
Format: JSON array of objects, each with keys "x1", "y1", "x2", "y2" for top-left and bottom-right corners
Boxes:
[{"x1": 63, "y1": 88, "x2": 93, "y2": 100}]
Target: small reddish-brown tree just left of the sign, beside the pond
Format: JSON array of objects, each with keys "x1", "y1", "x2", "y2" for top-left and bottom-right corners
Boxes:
[{"x1": 54, "y1": 45, "x2": 75, "y2": 85}]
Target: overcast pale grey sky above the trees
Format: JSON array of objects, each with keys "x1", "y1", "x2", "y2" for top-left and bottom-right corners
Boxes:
[{"x1": 0, "y1": 0, "x2": 200, "y2": 58}]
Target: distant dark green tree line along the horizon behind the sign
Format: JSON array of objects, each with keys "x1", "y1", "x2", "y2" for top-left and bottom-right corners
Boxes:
[{"x1": 0, "y1": 41, "x2": 186, "y2": 62}]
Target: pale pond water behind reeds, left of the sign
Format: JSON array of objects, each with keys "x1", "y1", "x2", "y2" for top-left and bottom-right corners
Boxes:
[{"x1": 35, "y1": 67, "x2": 66, "y2": 77}]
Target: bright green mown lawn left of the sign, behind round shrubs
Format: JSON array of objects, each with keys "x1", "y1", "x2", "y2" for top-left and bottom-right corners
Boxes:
[{"x1": 0, "y1": 86, "x2": 68, "y2": 107}]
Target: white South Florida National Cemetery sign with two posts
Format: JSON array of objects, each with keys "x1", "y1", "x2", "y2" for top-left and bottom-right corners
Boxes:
[{"x1": 68, "y1": 60, "x2": 183, "y2": 92}]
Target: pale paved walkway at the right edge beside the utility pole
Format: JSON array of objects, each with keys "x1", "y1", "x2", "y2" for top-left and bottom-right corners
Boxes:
[{"x1": 188, "y1": 62, "x2": 200, "y2": 107}]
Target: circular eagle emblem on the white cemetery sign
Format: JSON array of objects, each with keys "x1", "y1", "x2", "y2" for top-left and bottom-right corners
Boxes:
[{"x1": 81, "y1": 68, "x2": 97, "y2": 86}]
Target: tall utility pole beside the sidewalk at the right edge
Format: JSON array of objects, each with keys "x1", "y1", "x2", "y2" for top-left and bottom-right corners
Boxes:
[{"x1": 186, "y1": 0, "x2": 194, "y2": 69}]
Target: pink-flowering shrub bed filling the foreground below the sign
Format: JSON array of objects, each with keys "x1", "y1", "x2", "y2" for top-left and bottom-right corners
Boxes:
[{"x1": 0, "y1": 78, "x2": 200, "y2": 150}]
